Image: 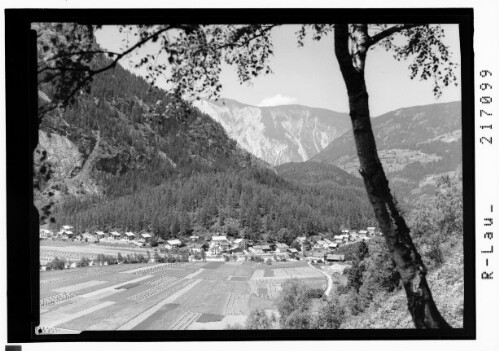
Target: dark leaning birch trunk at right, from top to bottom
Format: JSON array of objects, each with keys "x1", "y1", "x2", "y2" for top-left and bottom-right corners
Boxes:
[{"x1": 334, "y1": 24, "x2": 451, "y2": 328}]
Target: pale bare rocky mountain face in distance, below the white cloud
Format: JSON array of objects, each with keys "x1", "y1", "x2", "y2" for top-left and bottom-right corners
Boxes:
[{"x1": 194, "y1": 99, "x2": 350, "y2": 165}]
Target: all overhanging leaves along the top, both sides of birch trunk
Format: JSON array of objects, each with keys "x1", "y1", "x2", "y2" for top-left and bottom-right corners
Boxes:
[{"x1": 33, "y1": 23, "x2": 457, "y2": 116}]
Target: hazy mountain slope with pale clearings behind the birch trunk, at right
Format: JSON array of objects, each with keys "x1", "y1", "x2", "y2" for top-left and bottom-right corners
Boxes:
[{"x1": 312, "y1": 102, "x2": 462, "y2": 201}]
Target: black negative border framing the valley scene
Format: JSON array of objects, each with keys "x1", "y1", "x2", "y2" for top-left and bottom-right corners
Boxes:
[{"x1": 5, "y1": 9, "x2": 476, "y2": 342}]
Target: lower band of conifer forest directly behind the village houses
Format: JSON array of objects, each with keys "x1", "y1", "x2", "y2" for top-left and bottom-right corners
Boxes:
[{"x1": 55, "y1": 169, "x2": 372, "y2": 239}]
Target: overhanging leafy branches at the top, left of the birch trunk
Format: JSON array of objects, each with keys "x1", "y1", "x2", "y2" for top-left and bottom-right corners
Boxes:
[{"x1": 33, "y1": 23, "x2": 277, "y2": 116}]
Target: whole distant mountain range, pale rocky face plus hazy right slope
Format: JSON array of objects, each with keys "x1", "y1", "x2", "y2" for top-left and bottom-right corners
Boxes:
[{"x1": 194, "y1": 99, "x2": 462, "y2": 202}]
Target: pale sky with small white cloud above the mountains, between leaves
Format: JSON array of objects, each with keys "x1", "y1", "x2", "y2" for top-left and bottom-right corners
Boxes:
[{"x1": 96, "y1": 25, "x2": 461, "y2": 116}]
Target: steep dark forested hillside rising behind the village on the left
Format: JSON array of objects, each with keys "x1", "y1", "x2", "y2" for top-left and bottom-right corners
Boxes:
[{"x1": 35, "y1": 55, "x2": 373, "y2": 243}]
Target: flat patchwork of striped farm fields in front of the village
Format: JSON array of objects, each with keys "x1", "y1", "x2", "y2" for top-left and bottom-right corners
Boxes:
[{"x1": 40, "y1": 261, "x2": 327, "y2": 332}]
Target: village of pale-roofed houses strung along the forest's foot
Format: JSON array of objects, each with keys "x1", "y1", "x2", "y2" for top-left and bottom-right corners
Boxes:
[{"x1": 40, "y1": 225, "x2": 380, "y2": 270}]
